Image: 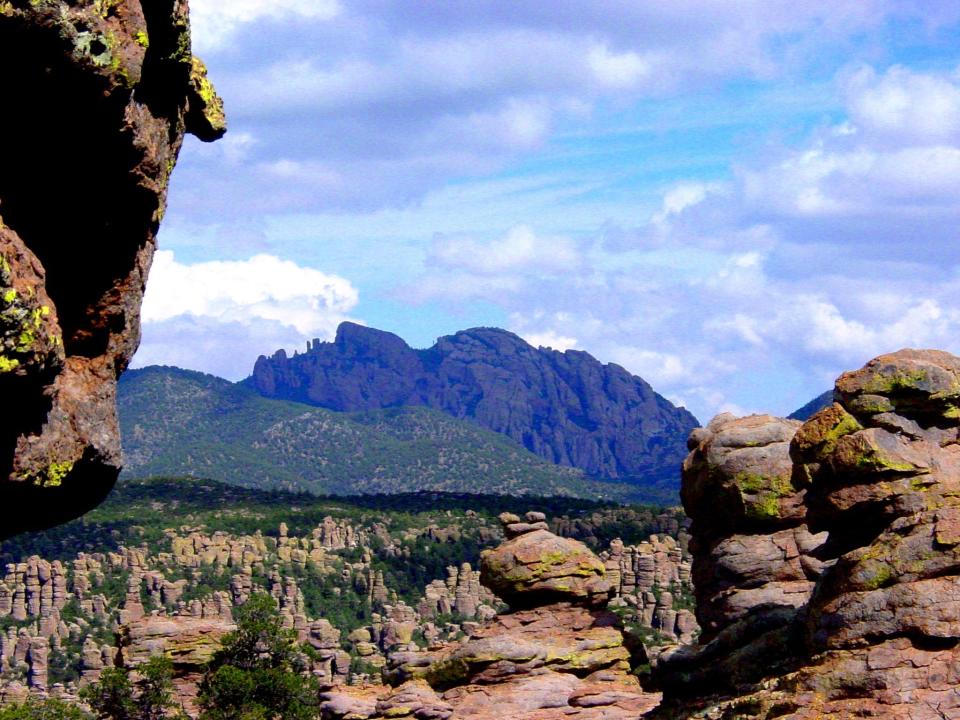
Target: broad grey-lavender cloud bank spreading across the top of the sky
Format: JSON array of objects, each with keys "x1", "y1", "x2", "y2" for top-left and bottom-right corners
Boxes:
[{"x1": 174, "y1": 0, "x2": 936, "y2": 214}]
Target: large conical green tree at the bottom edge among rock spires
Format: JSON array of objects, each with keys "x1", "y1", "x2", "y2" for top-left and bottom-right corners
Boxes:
[{"x1": 199, "y1": 593, "x2": 320, "y2": 720}]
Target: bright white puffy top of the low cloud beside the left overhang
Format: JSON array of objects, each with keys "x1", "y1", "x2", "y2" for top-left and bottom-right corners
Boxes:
[{"x1": 142, "y1": 250, "x2": 359, "y2": 337}]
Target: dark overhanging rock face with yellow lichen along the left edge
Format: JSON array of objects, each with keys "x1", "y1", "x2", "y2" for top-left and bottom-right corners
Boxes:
[{"x1": 0, "y1": 0, "x2": 225, "y2": 537}]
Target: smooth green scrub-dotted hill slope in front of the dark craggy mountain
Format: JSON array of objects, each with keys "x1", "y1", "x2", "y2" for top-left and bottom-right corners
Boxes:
[{"x1": 118, "y1": 367, "x2": 652, "y2": 499}]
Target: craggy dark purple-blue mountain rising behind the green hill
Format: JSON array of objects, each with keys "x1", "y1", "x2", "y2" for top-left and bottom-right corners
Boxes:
[{"x1": 245, "y1": 323, "x2": 698, "y2": 484}]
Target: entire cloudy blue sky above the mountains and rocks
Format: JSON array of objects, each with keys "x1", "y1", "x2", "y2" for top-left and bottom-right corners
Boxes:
[{"x1": 134, "y1": 0, "x2": 960, "y2": 422}]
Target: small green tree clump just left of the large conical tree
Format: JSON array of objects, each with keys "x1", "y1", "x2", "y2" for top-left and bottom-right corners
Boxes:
[{"x1": 81, "y1": 655, "x2": 184, "y2": 720}]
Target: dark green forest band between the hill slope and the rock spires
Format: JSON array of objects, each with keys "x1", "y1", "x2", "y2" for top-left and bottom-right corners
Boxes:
[{"x1": 0, "y1": 477, "x2": 682, "y2": 568}]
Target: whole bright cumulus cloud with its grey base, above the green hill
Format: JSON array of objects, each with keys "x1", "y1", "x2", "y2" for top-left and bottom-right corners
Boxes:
[{"x1": 135, "y1": 250, "x2": 359, "y2": 379}]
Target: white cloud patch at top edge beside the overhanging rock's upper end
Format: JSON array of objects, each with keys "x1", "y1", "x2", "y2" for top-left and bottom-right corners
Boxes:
[{"x1": 190, "y1": 0, "x2": 342, "y2": 52}]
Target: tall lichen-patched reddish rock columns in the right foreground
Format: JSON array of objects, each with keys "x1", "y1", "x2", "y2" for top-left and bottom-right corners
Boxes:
[{"x1": 650, "y1": 350, "x2": 960, "y2": 720}]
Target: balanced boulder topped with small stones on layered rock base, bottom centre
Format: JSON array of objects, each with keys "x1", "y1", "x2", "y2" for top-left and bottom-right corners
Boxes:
[{"x1": 323, "y1": 513, "x2": 659, "y2": 720}]
